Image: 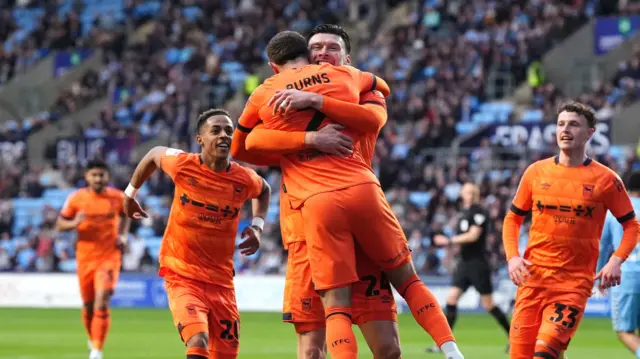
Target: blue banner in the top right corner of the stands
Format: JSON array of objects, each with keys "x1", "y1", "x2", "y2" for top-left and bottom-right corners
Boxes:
[{"x1": 593, "y1": 15, "x2": 640, "y2": 56}]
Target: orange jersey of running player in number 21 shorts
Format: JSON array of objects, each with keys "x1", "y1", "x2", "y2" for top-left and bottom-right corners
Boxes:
[{"x1": 159, "y1": 149, "x2": 264, "y2": 288}]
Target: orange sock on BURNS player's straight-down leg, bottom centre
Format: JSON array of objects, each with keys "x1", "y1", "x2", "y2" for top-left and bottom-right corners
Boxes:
[{"x1": 324, "y1": 307, "x2": 358, "y2": 359}]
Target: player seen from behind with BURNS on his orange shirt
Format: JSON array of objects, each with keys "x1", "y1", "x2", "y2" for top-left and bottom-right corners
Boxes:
[{"x1": 234, "y1": 31, "x2": 462, "y2": 359}]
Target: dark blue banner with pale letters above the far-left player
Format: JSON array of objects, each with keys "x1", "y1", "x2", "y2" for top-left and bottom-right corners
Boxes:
[{"x1": 56, "y1": 136, "x2": 135, "y2": 164}]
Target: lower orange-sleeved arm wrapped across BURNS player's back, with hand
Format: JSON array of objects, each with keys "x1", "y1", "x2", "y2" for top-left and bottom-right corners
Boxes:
[{"x1": 246, "y1": 124, "x2": 353, "y2": 156}]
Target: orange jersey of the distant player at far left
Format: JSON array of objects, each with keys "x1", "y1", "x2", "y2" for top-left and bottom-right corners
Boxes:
[{"x1": 60, "y1": 187, "x2": 124, "y2": 265}]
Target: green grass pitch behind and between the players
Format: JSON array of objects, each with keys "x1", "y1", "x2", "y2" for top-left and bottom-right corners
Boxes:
[{"x1": 0, "y1": 309, "x2": 633, "y2": 359}]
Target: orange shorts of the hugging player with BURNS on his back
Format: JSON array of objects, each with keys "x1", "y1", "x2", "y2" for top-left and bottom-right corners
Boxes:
[{"x1": 301, "y1": 183, "x2": 410, "y2": 290}]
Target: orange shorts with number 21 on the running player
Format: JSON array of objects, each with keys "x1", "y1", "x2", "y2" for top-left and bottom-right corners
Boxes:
[{"x1": 164, "y1": 271, "x2": 240, "y2": 358}]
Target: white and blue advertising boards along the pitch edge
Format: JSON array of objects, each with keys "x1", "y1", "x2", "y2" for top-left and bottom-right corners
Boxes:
[{"x1": 0, "y1": 273, "x2": 610, "y2": 316}]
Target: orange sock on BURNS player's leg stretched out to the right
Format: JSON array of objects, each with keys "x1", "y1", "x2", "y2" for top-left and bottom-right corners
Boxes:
[{"x1": 398, "y1": 274, "x2": 455, "y2": 347}]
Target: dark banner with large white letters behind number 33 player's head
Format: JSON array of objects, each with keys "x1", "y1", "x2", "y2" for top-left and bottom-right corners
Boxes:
[{"x1": 460, "y1": 120, "x2": 611, "y2": 155}]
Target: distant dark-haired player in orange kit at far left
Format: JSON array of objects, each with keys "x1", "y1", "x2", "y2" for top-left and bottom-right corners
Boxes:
[{"x1": 56, "y1": 159, "x2": 131, "y2": 359}]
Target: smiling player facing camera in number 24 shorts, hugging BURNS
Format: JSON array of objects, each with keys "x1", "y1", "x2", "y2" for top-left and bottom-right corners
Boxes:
[{"x1": 234, "y1": 25, "x2": 400, "y2": 358}]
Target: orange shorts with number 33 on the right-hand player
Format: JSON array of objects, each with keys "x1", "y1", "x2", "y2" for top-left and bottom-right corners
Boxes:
[{"x1": 509, "y1": 287, "x2": 589, "y2": 359}]
